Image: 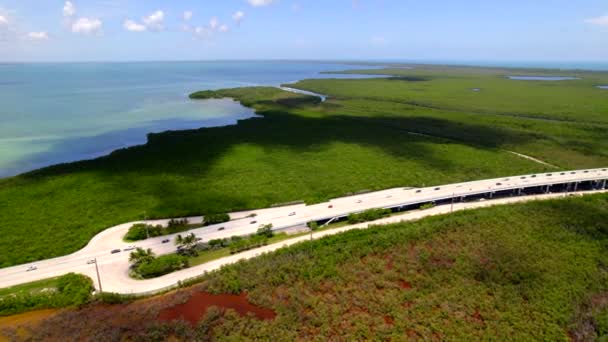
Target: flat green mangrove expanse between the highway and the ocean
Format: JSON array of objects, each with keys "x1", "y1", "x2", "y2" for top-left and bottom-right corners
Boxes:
[{"x1": 0, "y1": 68, "x2": 608, "y2": 267}]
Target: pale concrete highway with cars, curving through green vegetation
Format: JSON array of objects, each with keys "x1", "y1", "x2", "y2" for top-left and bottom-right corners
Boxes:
[{"x1": 0, "y1": 168, "x2": 608, "y2": 293}]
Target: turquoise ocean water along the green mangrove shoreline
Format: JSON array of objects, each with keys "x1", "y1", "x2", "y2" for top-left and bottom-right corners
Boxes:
[{"x1": 0, "y1": 62, "x2": 376, "y2": 177}]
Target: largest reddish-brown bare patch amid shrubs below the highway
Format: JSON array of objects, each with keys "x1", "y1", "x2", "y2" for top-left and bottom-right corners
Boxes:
[{"x1": 158, "y1": 292, "x2": 276, "y2": 325}]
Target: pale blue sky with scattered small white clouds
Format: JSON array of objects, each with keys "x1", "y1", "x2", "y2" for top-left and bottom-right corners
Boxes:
[{"x1": 0, "y1": 0, "x2": 608, "y2": 61}]
